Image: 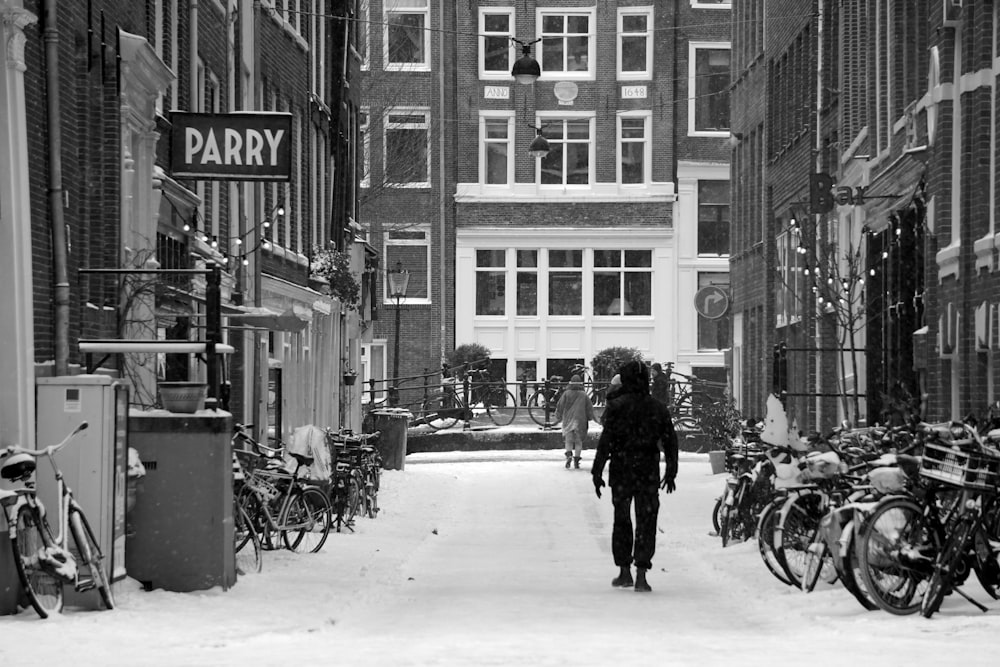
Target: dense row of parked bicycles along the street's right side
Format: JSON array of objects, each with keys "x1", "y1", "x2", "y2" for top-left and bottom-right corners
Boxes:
[{"x1": 713, "y1": 422, "x2": 1000, "y2": 618}]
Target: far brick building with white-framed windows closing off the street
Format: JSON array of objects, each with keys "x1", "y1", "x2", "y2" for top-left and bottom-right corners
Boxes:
[{"x1": 362, "y1": 0, "x2": 730, "y2": 401}]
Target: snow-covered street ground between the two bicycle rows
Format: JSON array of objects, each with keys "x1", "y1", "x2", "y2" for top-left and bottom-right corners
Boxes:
[{"x1": 0, "y1": 450, "x2": 1000, "y2": 667}]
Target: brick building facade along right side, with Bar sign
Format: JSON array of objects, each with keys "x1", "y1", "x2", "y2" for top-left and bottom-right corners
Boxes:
[{"x1": 732, "y1": 0, "x2": 1000, "y2": 430}]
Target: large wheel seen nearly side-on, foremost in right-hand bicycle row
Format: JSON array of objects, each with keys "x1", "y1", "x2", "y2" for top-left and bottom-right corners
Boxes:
[{"x1": 856, "y1": 497, "x2": 939, "y2": 616}]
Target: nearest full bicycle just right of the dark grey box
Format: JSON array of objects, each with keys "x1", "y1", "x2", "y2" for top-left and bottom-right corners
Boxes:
[{"x1": 233, "y1": 424, "x2": 333, "y2": 553}]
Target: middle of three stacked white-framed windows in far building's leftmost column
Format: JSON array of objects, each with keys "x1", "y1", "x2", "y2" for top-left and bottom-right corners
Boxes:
[{"x1": 383, "y1": 109, "x2": 430, "y2": 187}]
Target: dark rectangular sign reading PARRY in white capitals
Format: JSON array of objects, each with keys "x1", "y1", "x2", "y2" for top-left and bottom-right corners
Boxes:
[{"x1": 170, "y1": 111, "x2": 292, "y2": 181}]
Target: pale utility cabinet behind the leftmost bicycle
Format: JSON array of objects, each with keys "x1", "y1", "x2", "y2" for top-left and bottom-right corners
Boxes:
[{"x1": 35, "y1": 375, "x2": 129, "y2": 608}]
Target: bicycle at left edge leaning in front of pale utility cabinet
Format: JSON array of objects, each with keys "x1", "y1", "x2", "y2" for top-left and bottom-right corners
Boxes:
[{"x1": 0, "y1": 422, "x2": 115, "y2": 618}]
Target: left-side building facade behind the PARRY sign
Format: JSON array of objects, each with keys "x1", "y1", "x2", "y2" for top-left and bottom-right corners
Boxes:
[{"x1": 0, "y1": 0, "x2": 371, "y2": 448}]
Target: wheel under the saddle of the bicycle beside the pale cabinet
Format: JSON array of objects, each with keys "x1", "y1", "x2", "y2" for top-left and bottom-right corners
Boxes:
[{"x1": 11, "y1": 506, "x2": 63, "y2": 618}]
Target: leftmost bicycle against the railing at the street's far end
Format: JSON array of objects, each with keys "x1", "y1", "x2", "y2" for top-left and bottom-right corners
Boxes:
[{"x1": 417, "y1": 369, "x2": 517, "y2": 431}]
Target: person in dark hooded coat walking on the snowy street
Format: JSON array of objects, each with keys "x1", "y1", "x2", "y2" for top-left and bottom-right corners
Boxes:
[{"x1": 590, "y1": 361, "x2": 677, "y2": 592}]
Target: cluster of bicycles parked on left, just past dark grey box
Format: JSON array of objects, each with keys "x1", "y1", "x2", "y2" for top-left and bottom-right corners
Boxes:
[{"x1": 233, "y1": 424, "x2": 382, "y2": 574}]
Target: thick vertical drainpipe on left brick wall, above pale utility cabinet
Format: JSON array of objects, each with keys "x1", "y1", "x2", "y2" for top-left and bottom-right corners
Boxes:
[{"x1": 42, "y1": 0, "x2": 69, "y2": 375}]
